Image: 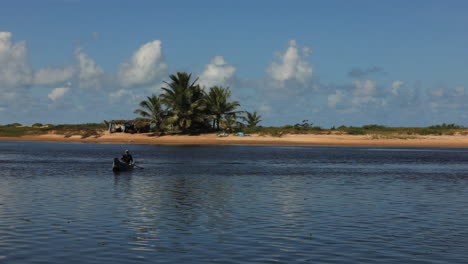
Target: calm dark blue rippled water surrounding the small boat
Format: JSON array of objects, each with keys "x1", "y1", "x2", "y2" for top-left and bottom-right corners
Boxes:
[{"x1": 0, "y1": 142, "x2": 468, "y2": 263}]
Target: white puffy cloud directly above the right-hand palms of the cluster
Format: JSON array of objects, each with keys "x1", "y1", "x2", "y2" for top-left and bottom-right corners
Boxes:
[{"x1": 200, "y1": 56, "x2": 236, "y2": 88}]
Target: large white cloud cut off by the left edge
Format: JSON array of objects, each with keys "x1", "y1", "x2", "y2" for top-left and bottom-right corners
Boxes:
[{"x1": 0, "y1": 32, "x2": 32, "y2": 88}]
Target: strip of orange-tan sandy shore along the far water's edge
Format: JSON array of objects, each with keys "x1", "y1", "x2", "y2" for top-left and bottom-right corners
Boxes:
[{"x1": 0, "y1": 132, "x2": 468, "y2": 148}]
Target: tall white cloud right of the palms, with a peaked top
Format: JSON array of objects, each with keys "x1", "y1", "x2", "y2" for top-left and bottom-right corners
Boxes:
[{"x1": 267, "y1": 40, "x2": 312, "y2": 83}]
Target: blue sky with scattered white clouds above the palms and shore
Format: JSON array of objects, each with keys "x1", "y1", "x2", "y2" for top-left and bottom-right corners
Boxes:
[{"x1": 0, "y1": 0, "x2": 468, "y2": 127}]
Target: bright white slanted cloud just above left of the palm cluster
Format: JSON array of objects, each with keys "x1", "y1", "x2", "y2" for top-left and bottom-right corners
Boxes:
[{"x1": 119, "y1": 40, "x2": 167, "y2": 87}]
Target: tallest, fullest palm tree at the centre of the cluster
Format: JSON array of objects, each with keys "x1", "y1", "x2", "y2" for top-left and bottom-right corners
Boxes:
[{"x1": 161, "y1": 72, "x2": 206, "y2": 132}]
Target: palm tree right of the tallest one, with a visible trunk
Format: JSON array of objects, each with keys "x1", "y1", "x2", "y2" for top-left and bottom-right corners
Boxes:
[{"x1": 206, "y1": 86, "x2": 240, "y2": 130}]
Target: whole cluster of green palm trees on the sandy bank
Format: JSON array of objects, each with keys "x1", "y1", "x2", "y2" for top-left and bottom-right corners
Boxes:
[{"x1": 134, "y1": 72, "x2": 261, "y2": 133}]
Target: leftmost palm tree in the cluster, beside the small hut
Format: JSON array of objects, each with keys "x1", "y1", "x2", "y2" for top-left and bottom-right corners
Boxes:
[{"x1": 133, "y1": 94, "x2": 167, "y2": 131}]
